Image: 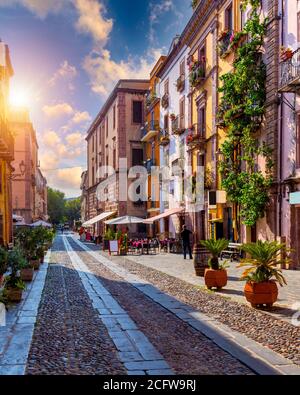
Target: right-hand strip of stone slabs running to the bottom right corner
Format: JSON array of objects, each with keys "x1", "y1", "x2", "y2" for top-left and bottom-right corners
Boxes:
[{"x1": 73, "y1": 238, "x2": 300, "y2": 374}]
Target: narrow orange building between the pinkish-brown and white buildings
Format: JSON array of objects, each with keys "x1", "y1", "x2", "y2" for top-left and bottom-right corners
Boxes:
[{"x1": 141, "y1": 56, "x2": 166, "y2": 235}]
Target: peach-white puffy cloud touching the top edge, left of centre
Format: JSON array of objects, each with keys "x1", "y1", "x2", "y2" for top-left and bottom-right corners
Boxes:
[{"x1": 74, "y1": 0, "x2": 113, "y2": 46}]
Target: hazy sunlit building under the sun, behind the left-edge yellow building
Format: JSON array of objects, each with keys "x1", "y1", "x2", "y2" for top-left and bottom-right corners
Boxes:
[{"x1": 10, "y1": 108, "x2": 48, "y2": 224}]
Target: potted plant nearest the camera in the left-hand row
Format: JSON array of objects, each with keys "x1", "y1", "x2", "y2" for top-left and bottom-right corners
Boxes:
[{"x1": 5, "y1": 248, "x2": 25, "y2": 302}]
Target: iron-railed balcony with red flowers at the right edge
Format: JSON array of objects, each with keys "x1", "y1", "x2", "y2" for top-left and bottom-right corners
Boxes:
[{"x1": 279, "y1": 48, "x2": 300, "y2": 93}]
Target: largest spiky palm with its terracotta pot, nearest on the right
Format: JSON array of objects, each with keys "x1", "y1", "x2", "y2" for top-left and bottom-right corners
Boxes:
[{"x1": 238, "y1": 240, "x2": 290, "y2": 307}]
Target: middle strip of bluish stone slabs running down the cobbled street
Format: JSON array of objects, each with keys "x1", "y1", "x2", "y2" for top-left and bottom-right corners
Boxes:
[{"x1": 63, "y1": 237, "x2": 171, "y2": 373}]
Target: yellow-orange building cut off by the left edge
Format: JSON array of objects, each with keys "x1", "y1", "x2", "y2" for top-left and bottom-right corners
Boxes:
[{"x1": 0, "y1": 41, "x2": 14, "y2": 245}]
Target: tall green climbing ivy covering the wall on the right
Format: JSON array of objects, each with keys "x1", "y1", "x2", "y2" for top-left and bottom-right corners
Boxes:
[{"x1": 218, "y1": 0, "x2": 273, "y2": 226}]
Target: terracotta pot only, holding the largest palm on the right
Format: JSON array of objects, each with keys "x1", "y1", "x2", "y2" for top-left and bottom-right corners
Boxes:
[{"x1": 244, "y1": 280, "x2": 278, "y2": 307}]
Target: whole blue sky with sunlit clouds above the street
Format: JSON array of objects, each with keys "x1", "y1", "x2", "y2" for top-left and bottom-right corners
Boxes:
[{"x1": 0, "y1": 0, "x2": 192, "y2": 197}]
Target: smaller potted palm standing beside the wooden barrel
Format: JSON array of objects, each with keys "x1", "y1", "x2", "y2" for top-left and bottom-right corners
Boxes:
[{"x1": 201, "y1": 239, "x2": 229, "y2": 290}]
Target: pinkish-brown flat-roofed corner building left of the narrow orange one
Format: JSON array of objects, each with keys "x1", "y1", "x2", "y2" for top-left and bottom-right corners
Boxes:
[{"x1": 86, "y1": 80, "x2": 149, "y2": 235}]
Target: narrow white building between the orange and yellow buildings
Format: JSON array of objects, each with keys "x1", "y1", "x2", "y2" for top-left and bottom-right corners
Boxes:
[{"x1": 158, "y1": 36, "x2": 189, "y2": 238}]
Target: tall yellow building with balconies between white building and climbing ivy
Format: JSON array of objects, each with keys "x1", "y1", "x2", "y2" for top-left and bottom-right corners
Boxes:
[{"x1": 183, "y1": 0, "x2": 247, "y2": 241}]
